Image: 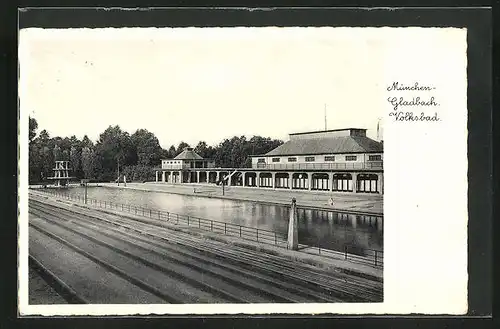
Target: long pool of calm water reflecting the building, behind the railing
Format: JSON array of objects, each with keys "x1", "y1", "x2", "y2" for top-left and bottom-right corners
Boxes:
[{"x1": 53, "y1": 187, "x2": 383, "y2": 255}]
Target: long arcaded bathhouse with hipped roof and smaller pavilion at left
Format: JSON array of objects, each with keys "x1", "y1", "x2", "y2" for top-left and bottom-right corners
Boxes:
[{"x1": 156, "y1": 128, "x2": 384, "y2": 194}]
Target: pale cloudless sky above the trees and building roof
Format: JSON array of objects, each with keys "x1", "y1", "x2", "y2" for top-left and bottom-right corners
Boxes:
[{"x1": 19, "y1": 27, "x2": 386, "y2": 148}]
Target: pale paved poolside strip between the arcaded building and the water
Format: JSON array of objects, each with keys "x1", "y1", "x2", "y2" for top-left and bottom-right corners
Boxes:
[{"x1": 99, "y1": 182, "x2": 383, "y2": 216}]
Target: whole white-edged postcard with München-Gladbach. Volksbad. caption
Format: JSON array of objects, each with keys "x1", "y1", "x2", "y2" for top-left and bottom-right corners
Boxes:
[{"x1": 19, "y1": 19, "x2": 468, "y2": 315}]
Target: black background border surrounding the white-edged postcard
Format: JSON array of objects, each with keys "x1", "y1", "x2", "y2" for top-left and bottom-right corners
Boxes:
[{"x1": 0, "y1": 5, "x2": 492, "y2": 328}]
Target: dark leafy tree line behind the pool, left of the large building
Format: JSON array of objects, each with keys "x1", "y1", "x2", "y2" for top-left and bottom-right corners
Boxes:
[{"x1": 29, "y1": 117, "x2": 283, "y2": 184}]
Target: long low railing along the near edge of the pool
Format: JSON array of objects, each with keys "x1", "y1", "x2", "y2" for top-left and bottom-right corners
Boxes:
[{"x1": 31, "y1": 189, "x2": 383, "y2": 266}]
